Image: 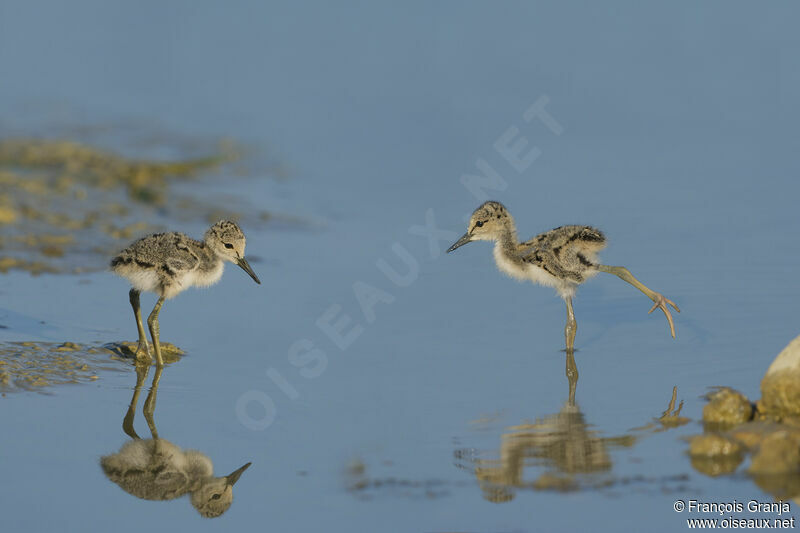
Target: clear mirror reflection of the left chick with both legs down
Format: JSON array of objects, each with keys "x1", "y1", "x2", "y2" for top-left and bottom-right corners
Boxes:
[{"x1": 100, "y1": 365, "x2": 250, "y2": 518}]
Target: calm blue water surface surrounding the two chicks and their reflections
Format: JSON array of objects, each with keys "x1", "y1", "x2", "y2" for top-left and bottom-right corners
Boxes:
[{"x1": 0, "y1": 1, "x2": 800, "y2": 532}]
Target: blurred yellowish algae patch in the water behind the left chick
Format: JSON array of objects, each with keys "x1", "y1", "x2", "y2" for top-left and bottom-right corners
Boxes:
[{"x1": 0, "y1": 139, "x2": 247, "y2": 274}]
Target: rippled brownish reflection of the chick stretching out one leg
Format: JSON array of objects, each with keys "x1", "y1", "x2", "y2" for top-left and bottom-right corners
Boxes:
[{"x1": 456, "y1": 352, "x2": 689, "y2": 503}]
